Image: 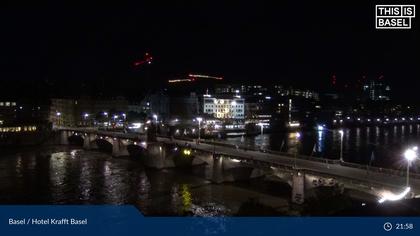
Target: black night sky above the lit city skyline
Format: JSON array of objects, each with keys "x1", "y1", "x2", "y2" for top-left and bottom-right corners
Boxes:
[{"x1": 0, "y1": 1, "x2": 420, "y2": 97}]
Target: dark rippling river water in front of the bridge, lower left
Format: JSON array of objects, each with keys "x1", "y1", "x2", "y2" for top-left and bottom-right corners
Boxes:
[{"x1": 0, "y1": 147, "x2": 296, "y2": 215}]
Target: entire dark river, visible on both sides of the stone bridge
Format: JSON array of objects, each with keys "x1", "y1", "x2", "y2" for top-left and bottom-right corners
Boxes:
[{"x1": 0, "y1": 125, "x2": 420, "y2": 216}]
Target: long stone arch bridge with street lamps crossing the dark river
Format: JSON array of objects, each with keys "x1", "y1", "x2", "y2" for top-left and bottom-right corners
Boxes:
[{"x1": 57, "y1": 128, "x2": 420, "y2": 203}]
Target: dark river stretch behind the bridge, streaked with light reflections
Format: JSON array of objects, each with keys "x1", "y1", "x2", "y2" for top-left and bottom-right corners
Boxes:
[{"x1": 227, "y1": 125, "x2": 420, "y2": 168}]
